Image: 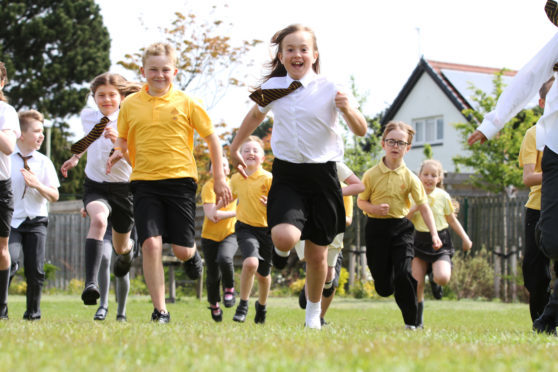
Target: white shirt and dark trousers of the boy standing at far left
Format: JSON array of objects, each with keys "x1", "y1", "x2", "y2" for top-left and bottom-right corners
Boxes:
[{"x1": 9, "y1": 146, "x2": 60, "y2": 319}]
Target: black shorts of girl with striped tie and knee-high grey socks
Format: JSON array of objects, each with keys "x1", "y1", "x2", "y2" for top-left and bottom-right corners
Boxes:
[{"x1": 83, "y1": 177, "x2": 134, "y2": 234}]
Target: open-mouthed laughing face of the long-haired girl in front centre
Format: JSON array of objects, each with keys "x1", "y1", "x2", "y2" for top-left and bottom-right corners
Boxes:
[{"x1": 278, "y1": 31, "x2": 318, "y2": 80}]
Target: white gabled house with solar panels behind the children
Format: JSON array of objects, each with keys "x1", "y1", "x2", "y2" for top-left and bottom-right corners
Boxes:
[{"x1": 382, "y1": 58, "x2": 538, "y2": 173}]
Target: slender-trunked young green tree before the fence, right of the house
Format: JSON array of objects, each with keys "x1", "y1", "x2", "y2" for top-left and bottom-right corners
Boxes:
[{"x1": 453, "y1": 71, "x2": 541, "y2": 299}]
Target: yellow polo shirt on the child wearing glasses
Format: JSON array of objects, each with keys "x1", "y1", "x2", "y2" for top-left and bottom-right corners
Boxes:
[{"x1": 358, "y1": 158, "x2": 426, "y2": 218}]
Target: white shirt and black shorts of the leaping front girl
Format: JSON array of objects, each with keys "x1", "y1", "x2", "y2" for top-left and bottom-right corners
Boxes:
[{"x1": 258, "y1": 70, "x2": 356, "y2": 245}]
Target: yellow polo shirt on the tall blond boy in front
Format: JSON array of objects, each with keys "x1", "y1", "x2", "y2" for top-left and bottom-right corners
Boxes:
[{"x1": 118, "y1": 84, "x2": 213, "y2": 181}]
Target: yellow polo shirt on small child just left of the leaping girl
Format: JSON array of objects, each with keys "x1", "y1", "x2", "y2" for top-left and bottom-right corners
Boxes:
[{"x1": 231, "y1": 168, "x2": 272, "y2": 227}]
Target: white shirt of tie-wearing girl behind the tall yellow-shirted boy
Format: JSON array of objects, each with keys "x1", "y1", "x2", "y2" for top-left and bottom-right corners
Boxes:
[{"x1": 81, "y1": 108, "x2": 132, "y2": 182}]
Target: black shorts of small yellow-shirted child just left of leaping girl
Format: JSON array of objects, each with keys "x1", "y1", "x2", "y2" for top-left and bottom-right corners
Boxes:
[{"x1": 234, "y1": 221, "x2": 273, "y2": 276}]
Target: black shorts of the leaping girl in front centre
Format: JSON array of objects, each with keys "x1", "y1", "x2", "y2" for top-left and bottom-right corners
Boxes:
[{"x1": 267, "y1": 158, "x2": 345, "y2": 246}]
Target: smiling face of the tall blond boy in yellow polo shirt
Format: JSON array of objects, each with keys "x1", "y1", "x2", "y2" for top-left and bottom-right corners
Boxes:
[{"x1": 140, "y1": 54, "x2": 178, "y2": 97}]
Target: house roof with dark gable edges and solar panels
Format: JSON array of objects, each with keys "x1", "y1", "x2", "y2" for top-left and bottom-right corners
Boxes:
[{"x1": 382, "y1": 58, "x2": 524, "y2": 125}]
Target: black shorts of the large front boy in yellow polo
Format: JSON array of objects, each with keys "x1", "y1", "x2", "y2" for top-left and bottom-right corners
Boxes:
[{"x1": 131, "y1": 178, "x2": 198, "y2": 247}]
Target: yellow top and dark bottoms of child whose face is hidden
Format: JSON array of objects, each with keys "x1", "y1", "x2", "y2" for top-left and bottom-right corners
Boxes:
[{"x1": 201, "y1": 179, "x2": 238, "y2": 304}]
